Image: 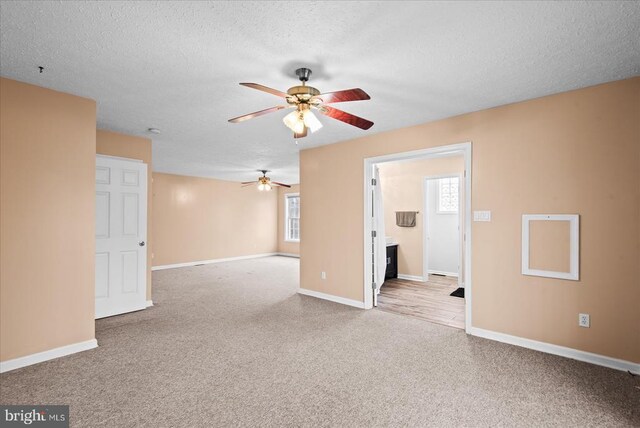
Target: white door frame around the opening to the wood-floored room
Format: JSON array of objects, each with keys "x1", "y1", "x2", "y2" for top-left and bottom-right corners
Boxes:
[{"x1": 362, "y1": 141, "x2": 472, "y2": 333}]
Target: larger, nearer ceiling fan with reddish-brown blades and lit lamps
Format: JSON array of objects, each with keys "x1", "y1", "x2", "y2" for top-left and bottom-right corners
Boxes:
[{"x1": 229, "y1": 68, "x2": 373, "y2": 138}]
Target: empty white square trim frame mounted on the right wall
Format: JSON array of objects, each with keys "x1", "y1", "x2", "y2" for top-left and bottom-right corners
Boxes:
[{"x1": 522, "y1": 214, "x2": 580, "y2": 281}]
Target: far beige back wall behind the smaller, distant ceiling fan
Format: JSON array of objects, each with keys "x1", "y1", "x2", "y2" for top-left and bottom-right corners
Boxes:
[{"x1": 153, "y1": 173, "x2": 278, "y2": 266}]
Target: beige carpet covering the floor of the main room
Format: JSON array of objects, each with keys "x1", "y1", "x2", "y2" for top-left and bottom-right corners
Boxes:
[{"x1": 0, "y1": 257, "x2": 640, "y2": 427}]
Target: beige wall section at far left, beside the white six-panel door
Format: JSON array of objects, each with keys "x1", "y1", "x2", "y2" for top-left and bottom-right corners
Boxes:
[{"x1": 0, "y1": 78, "x2": 96, "y2": 361}]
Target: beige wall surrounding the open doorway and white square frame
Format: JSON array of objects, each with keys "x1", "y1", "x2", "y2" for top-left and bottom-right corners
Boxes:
[{"x1": 300, "y1": 78, "x2": 640, "y2": 362}]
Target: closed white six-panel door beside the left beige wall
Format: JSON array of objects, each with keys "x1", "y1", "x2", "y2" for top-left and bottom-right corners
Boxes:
[{"x1": 95, "y1": 155, "x2": 147, "y2": 318}]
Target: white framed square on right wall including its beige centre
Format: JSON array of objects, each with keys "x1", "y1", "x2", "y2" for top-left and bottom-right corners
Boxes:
[{"x1": 522, "y1": 214, "x2": 580, "y2": 281}]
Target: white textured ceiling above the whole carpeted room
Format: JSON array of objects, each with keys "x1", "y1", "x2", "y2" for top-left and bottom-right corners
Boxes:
[{"x1": 0, "y1": 1, "x2": 640, "y2": 182}]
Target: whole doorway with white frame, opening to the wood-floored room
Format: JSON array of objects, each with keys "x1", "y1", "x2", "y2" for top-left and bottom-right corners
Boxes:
[{"x1": 364, "y1": 143, "x2": 472, "y2": 331}]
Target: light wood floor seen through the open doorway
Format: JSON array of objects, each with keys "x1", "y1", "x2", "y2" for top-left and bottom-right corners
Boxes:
[{"x1": 378, "y1": 275, "x2": 464, "y2": 329}]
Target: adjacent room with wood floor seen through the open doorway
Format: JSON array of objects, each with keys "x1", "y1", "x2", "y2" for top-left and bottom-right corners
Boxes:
[{"x1": 373, "y1": 156, "x2": 465, "y2": 330}]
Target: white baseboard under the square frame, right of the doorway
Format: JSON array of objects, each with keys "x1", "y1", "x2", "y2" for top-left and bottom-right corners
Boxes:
[{"x1": 467, "y1": 327, "x2": 640, "y2": 373}]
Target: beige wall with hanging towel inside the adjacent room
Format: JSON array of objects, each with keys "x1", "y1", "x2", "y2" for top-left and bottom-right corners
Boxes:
[{"x1": 379, "y1": 156, "x2": 464, "y2": 276}]
